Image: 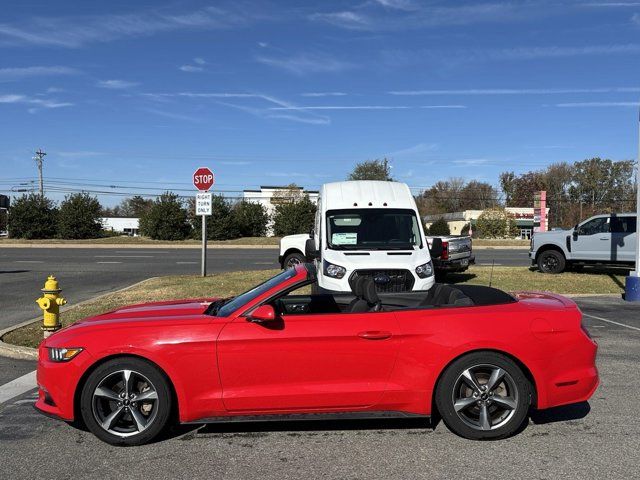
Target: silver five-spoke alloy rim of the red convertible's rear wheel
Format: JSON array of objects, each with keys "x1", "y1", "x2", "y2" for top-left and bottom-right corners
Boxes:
[{"x1": 451, "y1": 364, "x2": 518, "y2": 431}]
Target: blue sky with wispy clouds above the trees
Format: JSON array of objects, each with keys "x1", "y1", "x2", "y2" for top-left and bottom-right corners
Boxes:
[{"x1": 0, "y1": 0, "x2": 640, "y2": 204}]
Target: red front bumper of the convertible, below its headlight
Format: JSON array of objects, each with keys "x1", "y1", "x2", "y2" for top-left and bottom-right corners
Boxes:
[{"x1": 35, "y1": 345, "x2": 92, "y2": 421}]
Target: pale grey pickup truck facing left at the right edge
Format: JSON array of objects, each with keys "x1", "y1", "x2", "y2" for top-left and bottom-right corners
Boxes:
[{"x1": 529, "y1": 213, "x2": 638, "y2": 273}]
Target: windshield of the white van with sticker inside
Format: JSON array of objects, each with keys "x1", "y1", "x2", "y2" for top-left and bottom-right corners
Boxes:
[{"x1": 327, "y1": 208, "x2": 422, "y2": 250}]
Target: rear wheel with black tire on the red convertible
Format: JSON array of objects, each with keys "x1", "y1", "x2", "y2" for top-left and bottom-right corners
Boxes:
[{"x1": 435, "y1": 352, "x2": 531, "y2": 440}]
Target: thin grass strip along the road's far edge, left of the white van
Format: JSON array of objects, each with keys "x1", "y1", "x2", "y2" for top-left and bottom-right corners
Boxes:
[{"x1": 0, "y1": 235, "x2": 280, "y2": 245}]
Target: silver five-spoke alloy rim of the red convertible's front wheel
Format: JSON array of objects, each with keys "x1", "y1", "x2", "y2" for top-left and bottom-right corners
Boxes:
[{"x1": 91, "y1": 370, "x2": 158, "y2": 438}]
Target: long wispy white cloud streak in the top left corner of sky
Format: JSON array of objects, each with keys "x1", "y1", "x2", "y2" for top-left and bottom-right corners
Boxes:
[{"x1": 0, "y1": 4, "x2": 257, "y2": 48}]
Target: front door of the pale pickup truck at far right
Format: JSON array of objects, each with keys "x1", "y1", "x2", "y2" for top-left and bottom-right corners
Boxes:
[{"x1": 571, "y1": 215, "x2": 615, "y2": 262}]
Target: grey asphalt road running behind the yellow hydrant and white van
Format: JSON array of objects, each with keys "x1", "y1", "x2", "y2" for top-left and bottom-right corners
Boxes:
[{"x1": 0, "y1": 248, "x2": 529, "y2": 329}]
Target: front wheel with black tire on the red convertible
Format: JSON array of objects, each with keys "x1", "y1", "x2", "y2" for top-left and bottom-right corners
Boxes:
[{"x1": 80, "y1": 357, "x2": 172, "y2": 446}]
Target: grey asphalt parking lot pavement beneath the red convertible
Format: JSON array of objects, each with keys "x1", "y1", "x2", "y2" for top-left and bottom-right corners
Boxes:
[{"x1": 0, "y1": 297, "x2": 640, "y2": 480}]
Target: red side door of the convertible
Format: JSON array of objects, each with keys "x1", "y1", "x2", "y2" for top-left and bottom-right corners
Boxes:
[{"x1": 218, "y1": 312, "x2": 399, "y2": 412}]
